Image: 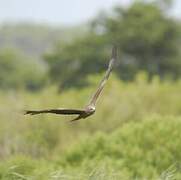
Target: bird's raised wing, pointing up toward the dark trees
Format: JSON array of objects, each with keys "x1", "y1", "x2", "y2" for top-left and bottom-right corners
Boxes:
[{"x1": 89, "y1": 46, "x2": 117, "y2": 106}]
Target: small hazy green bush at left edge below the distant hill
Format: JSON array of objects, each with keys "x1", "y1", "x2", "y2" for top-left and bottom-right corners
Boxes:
[{"x1": 0, "y1": 49, "x2": 47, "y2": 90}]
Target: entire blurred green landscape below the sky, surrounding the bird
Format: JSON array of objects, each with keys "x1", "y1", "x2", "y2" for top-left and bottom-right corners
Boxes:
[{"x1": 0, "y1": 0, "x2": 181, "y2": 180}]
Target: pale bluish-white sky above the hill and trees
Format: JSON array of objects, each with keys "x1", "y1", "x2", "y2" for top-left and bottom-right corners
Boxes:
[{"x1": 0, "y1": 0, "x2": 181, "y2": 25}]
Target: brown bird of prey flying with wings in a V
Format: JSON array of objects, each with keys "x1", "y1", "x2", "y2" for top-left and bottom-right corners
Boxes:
[{"x1": 25, "y1": 46, "x2": 117, "y2": 121}]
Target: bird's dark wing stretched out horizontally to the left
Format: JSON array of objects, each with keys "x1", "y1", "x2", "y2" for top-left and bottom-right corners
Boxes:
[{"x1": 24, "y1": 109, "x2": 85, "y2": 115}]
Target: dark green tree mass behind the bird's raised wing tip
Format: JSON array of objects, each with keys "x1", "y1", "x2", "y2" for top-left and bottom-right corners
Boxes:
[{"x1": 45, "y1": 1, "x2": 181, "y2": 87}]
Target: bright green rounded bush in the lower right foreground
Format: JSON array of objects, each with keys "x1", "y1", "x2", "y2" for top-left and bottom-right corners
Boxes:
[{"x1": 60, "y1": 116, "x2": 181, "y2": 179}]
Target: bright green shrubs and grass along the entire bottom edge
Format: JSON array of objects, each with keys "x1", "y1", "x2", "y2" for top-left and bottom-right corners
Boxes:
[{"x1": 0, "y1": 116, "x2": 181, "y2": 180}]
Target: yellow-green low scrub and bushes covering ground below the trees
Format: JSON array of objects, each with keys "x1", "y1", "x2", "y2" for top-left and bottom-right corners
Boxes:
[{"x1": 0, "y1": 73, "x2": 181, "y2": 179}]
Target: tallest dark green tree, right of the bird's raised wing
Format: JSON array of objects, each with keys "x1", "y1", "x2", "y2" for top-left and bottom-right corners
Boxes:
[{"x1": 93, "y1": 1, "x2": 181, "y2": 78}]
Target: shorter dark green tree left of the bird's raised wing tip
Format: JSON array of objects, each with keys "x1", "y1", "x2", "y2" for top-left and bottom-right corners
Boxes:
[{"x1": 44, "y1": 34, "x2": 110, "y2": 88}]
